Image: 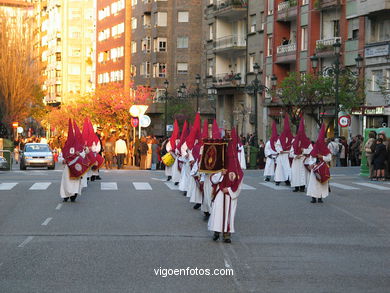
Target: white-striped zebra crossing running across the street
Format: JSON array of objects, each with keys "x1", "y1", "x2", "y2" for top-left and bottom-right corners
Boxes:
[{"x1": 0, "y1": 180, "x2": 390, "y2": 192}]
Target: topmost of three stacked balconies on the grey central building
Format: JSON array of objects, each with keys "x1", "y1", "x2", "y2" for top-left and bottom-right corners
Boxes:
[{"x1": 214, "y1": 0, "x2": 248, "y2": 21}]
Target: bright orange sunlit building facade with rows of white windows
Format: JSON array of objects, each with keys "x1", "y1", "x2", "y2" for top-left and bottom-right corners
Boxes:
[{"x1": 95, "y1": 0, "x2": 131, "y2": 92}]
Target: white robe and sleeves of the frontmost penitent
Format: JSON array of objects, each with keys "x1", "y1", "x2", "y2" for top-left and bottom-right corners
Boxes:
[{"x1": 208, "y1": 173, "x2": 241, "y2": 233}]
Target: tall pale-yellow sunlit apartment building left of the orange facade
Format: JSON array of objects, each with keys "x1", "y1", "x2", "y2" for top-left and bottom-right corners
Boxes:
[{"x1": 45, "y1": 0, "x2": 95, "y2": 105}]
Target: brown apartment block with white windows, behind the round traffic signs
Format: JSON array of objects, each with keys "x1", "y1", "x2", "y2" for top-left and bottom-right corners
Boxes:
[{"x1": 131, "y1": 0, "x2": 207, "y2": 135}]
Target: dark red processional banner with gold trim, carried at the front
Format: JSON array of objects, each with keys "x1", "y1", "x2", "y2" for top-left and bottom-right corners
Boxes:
[{"x1": 199, "y1": 139, "x2": 228, "y2": 173}]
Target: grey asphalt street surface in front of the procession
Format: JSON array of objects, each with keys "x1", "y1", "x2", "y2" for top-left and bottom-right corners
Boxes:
[{"x1": 0, "y1": 167, "x2": 390, "y2": 293}]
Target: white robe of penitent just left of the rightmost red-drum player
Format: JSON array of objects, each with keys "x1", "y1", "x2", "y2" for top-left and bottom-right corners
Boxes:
[{"x1": 290, "y1": 144, "x2": 313, "y2": 187}]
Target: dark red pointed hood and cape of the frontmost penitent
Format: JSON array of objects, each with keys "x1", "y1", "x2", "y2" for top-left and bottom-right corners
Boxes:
[{"x1": 220, "y1": 128, "x2": 244, "y2": 192}]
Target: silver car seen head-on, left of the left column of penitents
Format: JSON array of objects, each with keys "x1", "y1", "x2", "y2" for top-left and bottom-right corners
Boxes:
[{"x1": 20, "y1": 143, "x2": 55, "y2": 170}]
